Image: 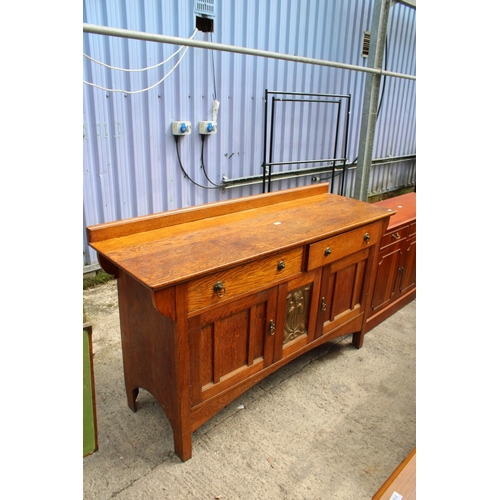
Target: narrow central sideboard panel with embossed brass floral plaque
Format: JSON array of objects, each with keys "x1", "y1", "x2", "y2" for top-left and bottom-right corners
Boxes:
[{"x1": 274, "y1": 269, "x2": 321, "y2": 361}]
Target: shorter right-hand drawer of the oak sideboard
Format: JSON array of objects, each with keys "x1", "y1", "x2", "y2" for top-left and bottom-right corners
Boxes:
[{"x1": 307, "y1": 222, "x2": 382, "y2": 271}]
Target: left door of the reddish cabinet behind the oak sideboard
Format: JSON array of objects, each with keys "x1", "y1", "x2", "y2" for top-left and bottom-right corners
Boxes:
[{"x1": 370, "y1": 244, "x2": 403, "y2": 313}]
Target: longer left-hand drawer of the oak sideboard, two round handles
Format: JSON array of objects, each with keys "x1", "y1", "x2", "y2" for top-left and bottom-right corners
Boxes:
[{"x1": 187, "y1": 247, "x2": 303, "y2": 313}]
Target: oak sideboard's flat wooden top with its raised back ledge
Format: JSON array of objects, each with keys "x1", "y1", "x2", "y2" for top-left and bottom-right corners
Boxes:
[{"x1": 87, "y1": 184, "x2": 394, "y2": 290}]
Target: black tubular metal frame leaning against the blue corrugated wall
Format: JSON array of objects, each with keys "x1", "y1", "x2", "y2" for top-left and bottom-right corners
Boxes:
[{"x1": 262, "y1": 89, "x2": 351, "y2": 195}]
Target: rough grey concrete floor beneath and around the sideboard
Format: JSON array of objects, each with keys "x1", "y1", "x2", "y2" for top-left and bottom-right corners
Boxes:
[{"x1": 83, "y1": 282, "x2": 416, "y2": 500}]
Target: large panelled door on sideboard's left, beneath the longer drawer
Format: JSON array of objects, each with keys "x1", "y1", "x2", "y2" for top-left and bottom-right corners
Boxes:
[{"x1": 188, "y1": 287, "x2": 277, "y2": 406}]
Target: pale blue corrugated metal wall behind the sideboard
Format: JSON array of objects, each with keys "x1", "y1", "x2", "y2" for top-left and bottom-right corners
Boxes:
[{"x1": 83, "y1": 0, "x2": 416, "y2": 265}]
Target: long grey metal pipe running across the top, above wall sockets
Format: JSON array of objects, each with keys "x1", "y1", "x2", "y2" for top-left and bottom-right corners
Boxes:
[{"x1": 83, "y1": 23, "x2": 417, "y2": 80}]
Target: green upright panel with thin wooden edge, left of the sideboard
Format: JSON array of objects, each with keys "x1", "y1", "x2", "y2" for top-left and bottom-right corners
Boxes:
[{"x1": 83, "y1": 325, "x2": 97, "y2": 457}]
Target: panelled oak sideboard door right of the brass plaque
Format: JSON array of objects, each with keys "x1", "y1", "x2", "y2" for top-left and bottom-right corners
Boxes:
[{"x1": 316, "y1": 248, "x2": 371, "y2": 337}]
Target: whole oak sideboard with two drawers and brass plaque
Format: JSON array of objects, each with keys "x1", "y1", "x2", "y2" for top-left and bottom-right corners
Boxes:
[{"x1": 87, "y1": 184, "x2": 392, "y2": 461}]
